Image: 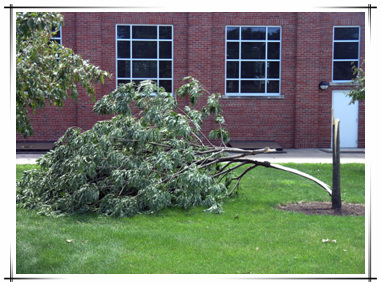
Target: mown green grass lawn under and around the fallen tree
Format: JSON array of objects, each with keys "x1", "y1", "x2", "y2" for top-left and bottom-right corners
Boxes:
[{"x1": 16, "y1": 164, "x2": 365, "y2": 274}]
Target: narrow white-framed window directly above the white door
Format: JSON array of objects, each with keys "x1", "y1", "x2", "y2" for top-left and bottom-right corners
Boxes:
[{"x1": 332, "y1": 26, "x2": 360, "y2": 82}]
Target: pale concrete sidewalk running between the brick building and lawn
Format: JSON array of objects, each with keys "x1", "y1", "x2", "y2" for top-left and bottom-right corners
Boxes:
[{"x1": 16, "y1": 149, "x2": 365, "y2": 164}]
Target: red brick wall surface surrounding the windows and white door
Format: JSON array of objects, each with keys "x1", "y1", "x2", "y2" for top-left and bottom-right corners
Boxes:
[{"x1": 17, "y1": 12, "x2": 365, "y2": 148}]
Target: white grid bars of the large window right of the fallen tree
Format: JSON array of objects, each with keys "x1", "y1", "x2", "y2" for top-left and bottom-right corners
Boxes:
[{"x1": 225, "y1": 26, "x2": 282, "y2": 96}]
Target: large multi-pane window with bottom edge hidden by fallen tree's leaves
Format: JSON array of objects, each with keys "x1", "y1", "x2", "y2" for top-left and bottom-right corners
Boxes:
[{"x1": 115, "y1": 24, "x2": 173, "y2": 93}]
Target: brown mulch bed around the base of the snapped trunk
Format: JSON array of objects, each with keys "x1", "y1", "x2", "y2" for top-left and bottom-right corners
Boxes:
[{"x1": 276, "y1": 202, "x2": 365, "y2": 216}]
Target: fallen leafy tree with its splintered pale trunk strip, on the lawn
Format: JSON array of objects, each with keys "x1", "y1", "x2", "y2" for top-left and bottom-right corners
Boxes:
[{"x1": 17, "y1": 77, "x2": 331, "y2": 216}]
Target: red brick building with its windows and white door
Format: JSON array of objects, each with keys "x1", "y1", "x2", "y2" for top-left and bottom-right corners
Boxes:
[{"x1": 17, "y1": 12, "x2": 365, "y2": 148}]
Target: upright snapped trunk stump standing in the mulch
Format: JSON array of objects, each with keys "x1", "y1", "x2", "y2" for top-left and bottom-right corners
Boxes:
[{"x1": 332, "y1": 119, "x2": 341, "y2": 210}]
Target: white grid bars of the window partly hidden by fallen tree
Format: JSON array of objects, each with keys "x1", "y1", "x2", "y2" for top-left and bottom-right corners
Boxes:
[{"x1": 115, "y1": 24, "x2": 173, "y2": 93}]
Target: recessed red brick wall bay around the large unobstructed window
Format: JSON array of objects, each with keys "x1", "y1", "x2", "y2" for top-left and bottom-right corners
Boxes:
[{"x1": 212, "y1": 13, "x2": 296, "y2": 147}]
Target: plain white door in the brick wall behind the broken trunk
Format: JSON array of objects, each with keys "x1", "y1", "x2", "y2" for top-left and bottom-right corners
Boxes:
[{"x1": 332, "y1": 90, "x2": 359, "y2": 148}]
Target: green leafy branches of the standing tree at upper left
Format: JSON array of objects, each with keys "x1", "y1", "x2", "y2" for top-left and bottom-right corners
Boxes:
[{"x1": 16, "y1": 12, "x2": 110, "y2": 137}]
